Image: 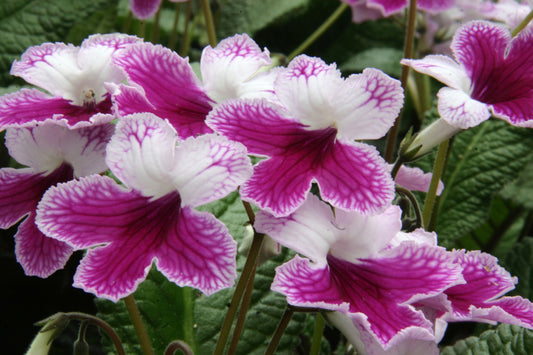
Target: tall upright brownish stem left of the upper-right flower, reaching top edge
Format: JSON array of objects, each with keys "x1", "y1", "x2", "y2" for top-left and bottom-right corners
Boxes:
[{"x1": 385, "y1": 0, "x2": 416, "y2": 163}]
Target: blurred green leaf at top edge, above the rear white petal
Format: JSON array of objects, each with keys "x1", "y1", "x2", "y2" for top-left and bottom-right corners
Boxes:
[{"x1": 217, "y1": 0, "x2": 309, "y2": 38}]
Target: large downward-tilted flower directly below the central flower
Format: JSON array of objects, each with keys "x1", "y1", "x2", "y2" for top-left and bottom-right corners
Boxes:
[{"x1": 255, "y1": 195, "x2": 464, "y2": 349}]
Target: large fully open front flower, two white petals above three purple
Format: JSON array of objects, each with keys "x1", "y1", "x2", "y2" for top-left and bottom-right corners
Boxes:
[{"x1": 37, "y1": 113, "x2": 252, "y2": 301}]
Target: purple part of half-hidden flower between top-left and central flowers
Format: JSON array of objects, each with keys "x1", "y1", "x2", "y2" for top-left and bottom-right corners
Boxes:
[{"x1": 114, "y1": 43, "x2": 212, "y2": 138}]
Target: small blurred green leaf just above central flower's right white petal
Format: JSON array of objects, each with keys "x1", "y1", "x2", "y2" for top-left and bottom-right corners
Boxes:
[{"x1": 340, "y1": 48, "x2": 403, "y2": 78}]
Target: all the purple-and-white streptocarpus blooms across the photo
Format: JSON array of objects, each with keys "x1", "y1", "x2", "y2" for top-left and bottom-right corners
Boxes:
[{"x1": 0, "y1": 6, "x2": 533, "y2": 354}]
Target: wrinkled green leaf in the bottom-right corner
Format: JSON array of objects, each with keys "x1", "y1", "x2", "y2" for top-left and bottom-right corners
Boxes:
[{"x1": 441, "y1": 324, "x2": 533, "y2": 355}]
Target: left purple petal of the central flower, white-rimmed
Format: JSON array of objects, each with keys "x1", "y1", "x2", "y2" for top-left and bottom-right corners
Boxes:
[{"x1": 206, "y1": 99, "x2": 305, "y2": 156}]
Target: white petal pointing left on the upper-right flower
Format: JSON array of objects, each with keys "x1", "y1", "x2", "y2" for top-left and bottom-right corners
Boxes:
[{"x1": 401, "y1": 55, "x2": 471, "y2": 92}]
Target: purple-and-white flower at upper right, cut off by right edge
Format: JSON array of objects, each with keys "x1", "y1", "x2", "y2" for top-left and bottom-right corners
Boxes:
[{"x1": 402, "y1": 21, "x2": 533, "y2": 129}]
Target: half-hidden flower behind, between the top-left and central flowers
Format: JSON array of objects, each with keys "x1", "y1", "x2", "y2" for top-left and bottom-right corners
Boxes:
[{"x1": 108, "y1": 34, "x2": 273, "y2": 138}]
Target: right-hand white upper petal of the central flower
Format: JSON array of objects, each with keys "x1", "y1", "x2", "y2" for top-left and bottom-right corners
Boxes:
[{"x1": 330, "y1": 68, "x2": 403, "y2": 141}]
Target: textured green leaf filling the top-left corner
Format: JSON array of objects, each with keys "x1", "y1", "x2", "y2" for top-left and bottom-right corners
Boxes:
[{"x1": 0, "y1": 0, "x2": 118, "y2": 86}]
